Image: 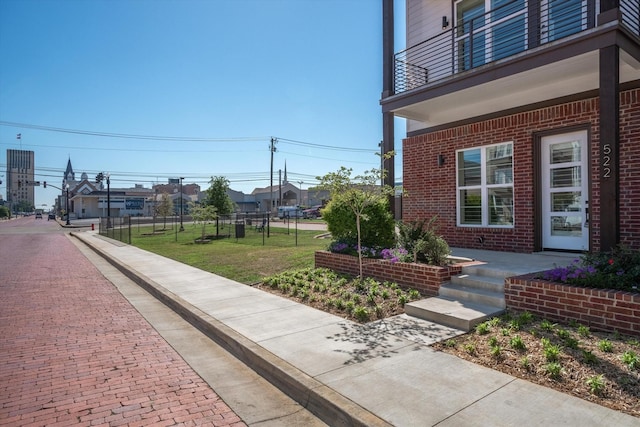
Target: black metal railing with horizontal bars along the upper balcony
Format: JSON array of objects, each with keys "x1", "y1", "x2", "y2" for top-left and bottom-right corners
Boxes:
[{"x1": 394, "y1": 0, "x2": 640, "y2": 94}]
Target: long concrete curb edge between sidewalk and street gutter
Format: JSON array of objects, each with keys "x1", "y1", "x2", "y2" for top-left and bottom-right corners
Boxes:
[{"x1": 70, "y1": 232, "x2": 391, "y2": 427}]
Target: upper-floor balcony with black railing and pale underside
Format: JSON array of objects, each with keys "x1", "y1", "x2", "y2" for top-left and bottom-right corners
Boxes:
[{"x1": 382, "y1": 0, "x2": 640, "y2": 126}]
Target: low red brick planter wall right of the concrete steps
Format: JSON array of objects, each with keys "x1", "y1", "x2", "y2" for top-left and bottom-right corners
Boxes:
[{"x1": 504, "y1": 274, "x2": 640, "y2": 336}]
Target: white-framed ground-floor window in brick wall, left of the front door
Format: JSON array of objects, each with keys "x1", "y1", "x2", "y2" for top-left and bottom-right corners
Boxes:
[{"x1": 456, "y1": 142, "x2": 513, "y2": 227}]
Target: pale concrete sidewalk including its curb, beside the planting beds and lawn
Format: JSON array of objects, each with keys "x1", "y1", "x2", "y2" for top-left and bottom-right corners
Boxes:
[{"x1": 73, "y1": 232, "x2": 640, "y2": 427}]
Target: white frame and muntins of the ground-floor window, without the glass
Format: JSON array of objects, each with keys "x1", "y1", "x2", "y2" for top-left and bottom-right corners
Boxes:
[{"x1": 455, "y1": 141, "x2": 515, "y2": 228}]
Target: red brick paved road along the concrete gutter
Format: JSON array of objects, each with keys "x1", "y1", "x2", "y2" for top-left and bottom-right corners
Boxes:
[{"x1": 0, "y1": 224, "x2": 245, "y2": 426}]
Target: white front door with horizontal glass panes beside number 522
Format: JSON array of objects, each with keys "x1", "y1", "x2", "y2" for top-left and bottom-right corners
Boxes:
[{"x1": 541, "y1": 131, "x2": 589, "y2": 251}]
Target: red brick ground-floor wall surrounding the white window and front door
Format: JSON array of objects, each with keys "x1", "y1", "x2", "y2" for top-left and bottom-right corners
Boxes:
[{"x1": 403, "y1": 89, "x2": 640, "y2": 252}]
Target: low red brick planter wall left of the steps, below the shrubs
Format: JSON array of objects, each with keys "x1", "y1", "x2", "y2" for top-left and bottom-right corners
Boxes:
[{"x1": 315, "y1": 251, "x2": 462, "y2": 296}]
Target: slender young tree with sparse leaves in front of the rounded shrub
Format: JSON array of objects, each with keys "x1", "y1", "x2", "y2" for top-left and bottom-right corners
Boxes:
[{"x1": 317, "y1": 152, "x2": 394, "y2": 277}]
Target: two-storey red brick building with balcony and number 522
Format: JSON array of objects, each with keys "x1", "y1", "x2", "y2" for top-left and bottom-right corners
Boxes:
[{"x1": 381, "y1": 0, "x2": 640, "y2": 252}]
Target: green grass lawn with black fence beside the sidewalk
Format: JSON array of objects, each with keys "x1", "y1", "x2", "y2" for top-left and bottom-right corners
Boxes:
[{"x1": 131, "y1": 224, "x2": 329, "y2": 284}]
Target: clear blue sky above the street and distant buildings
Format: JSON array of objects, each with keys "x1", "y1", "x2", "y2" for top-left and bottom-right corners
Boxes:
[{"x1": 0, "y1": 0, "x2": 404, "y2": 207}]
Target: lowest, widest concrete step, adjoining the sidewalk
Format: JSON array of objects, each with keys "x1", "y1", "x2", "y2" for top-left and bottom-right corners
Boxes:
[{"x1": 404, "y1": 297, "x2": 504, "y2": 332}]
